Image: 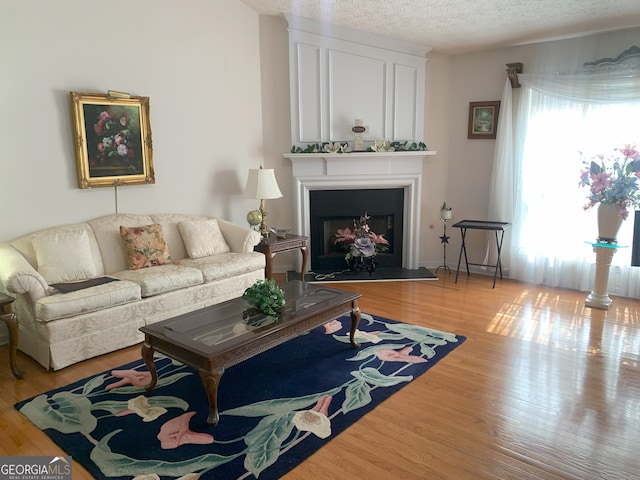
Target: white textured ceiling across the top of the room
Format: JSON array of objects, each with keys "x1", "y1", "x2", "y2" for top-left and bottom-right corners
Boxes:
[{"x1": 242, "y1": 0, "x2": 640, "y2": 54}]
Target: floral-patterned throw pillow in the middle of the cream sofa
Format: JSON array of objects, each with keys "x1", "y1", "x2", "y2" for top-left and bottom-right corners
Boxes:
[{"x1": 120, "y1": 223, "x2": 171, "y2": 270}]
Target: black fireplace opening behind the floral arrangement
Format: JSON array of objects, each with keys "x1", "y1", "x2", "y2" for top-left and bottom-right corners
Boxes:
[{"x1": 309, "y1": 188, "x2": 404, "y2": 272}]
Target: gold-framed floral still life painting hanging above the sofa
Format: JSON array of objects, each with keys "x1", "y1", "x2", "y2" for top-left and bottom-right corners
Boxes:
[{"x1": 70, "y1": 92, "x2": 155, "y2": 188}]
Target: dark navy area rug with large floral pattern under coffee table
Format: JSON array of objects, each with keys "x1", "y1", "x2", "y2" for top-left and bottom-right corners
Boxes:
[{"x1": 15, "y1": 314, "x2": 465, "y2": 480}]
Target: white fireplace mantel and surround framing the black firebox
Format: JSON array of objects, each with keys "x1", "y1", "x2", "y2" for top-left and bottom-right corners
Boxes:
[{"x1": 284, "y1": 150, "x2": 436, "y2": 270}]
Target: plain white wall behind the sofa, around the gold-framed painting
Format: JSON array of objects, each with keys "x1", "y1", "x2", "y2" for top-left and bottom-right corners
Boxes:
[{"x1": 0, "y1": 0, "x2": 264, "y2": 241}]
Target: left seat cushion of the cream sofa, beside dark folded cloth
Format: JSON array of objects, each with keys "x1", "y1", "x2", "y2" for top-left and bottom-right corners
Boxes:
[{"x1": 35, "y1": 282, "x2": 141, "y2": 322}]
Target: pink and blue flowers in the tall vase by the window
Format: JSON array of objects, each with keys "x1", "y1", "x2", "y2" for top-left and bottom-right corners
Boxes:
[{"x1": 579, "y1": 144, "x2": 640, "y2": 219}]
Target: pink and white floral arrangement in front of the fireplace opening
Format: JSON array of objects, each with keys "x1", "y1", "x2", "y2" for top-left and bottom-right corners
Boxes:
[{"x1": 333, "y1": 212, "x2": 389, "y2": 273}]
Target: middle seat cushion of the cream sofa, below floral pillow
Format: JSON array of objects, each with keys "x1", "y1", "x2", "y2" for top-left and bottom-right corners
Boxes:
[{"x1": 111, "y1": 265, "x2": 203, "y2": 298}]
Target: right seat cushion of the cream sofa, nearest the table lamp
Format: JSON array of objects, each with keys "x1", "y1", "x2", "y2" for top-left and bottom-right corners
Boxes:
[{"x1": 180, "y1": 252, "x2": 265, "y2": 283}]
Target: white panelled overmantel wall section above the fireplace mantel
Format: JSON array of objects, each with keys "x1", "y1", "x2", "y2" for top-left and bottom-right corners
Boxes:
[{"x1": 286, "y1": 15, "x2": 430, "y2": 150}]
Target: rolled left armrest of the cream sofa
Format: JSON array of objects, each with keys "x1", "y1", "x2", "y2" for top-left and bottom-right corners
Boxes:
[{"x1": 0, "y1": 243, "x2": 49, "y2": 302}]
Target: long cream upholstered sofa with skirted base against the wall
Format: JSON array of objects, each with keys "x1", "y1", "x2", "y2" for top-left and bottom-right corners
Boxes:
[{"x1": 0, "y1": 214, "x2": 265, "y2": 370}]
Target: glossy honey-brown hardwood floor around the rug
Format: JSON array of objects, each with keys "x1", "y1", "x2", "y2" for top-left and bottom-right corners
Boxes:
[{"x1": 0, "y1": 274, "x2": 640, "y2": 480}]
